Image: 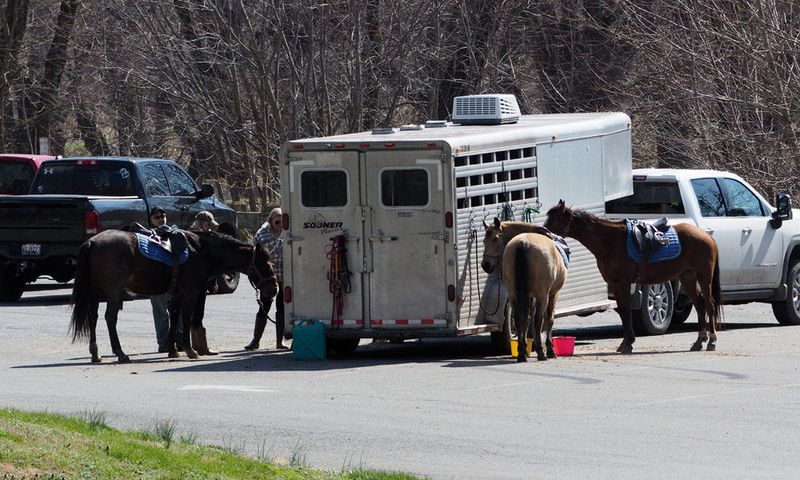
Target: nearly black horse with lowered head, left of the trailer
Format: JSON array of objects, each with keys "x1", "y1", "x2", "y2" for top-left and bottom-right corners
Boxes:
[{"x1": 70, "y1": 230, "x2": 277, "y2": 363}]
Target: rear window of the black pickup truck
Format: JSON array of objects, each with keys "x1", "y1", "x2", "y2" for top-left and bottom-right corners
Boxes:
[{"x1": 31, "y1": 160, "x2": 136, "y2": 197}]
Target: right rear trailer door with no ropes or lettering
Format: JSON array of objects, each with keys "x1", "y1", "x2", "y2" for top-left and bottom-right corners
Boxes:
[{"x1": 364, "y1": 150, "x2": 449, "y2": 329}]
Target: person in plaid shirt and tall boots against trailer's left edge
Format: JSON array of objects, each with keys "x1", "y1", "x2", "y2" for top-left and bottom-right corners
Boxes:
[{"x1": 244, "y1": 208, "x2": 288, "y2": 351}]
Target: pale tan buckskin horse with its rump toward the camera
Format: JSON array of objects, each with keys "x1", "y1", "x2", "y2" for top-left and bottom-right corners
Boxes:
[{"x1": 481, "y1": 218, "x2": 567, "y2": 362}]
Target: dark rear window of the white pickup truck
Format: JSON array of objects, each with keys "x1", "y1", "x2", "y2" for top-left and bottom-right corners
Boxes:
[{"x1": 606, "y1": 182, "x2": 686, "y2": 215}]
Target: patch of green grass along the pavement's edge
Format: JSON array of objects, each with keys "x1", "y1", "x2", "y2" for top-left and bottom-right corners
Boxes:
[{"x1": 0, "y1": 409, "x2": 419, "y2": 480}]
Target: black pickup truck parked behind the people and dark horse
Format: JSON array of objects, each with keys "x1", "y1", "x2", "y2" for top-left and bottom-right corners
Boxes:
[{"x1": 0, "y1": 157, "x2": 239, "y2": 302}]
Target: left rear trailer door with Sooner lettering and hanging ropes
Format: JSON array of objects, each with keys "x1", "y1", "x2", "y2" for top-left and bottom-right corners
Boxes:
[{"x1": 284, "y1": 151, "x2": 364, "y2": 329}]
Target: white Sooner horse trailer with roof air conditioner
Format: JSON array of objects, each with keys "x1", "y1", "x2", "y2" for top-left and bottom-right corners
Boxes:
[{"x1": 280, "y1": 95, "x2": 633, "y2": 352}]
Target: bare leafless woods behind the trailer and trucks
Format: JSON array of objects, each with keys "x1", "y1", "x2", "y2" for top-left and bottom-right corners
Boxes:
[{"x1": 0, "y1": 0, "x2": 800, "y2": 210}]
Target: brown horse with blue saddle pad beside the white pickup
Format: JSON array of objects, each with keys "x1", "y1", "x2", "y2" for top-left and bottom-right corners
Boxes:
[{"x1": 544, "y1": 200, "x2": 722, "y2": 353}]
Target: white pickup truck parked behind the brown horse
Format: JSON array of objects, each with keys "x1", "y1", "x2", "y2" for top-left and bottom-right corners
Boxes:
[{"x1": 606, "y1": 169, "x2": 800, "y2": 335}]
